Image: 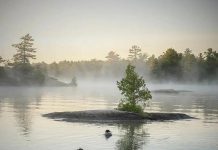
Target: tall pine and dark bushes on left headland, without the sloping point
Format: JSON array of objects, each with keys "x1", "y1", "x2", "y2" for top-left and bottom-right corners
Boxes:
[{"x1": 0, "y1": 34, "x2": 45, "y2": 85}]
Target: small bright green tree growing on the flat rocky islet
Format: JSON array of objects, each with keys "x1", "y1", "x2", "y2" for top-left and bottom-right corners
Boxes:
[{"x1": 117, "y1": 64, "x2": 152, "y2": 113}]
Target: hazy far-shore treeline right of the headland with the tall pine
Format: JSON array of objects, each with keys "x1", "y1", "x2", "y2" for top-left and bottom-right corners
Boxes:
[{"x1": 35, "y1": 46, "x2": 218, "y2": 82}]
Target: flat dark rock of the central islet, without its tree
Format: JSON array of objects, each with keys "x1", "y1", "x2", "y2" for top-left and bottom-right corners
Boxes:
[{"x1": 43, "y1": 110, "x2": 193, "y2": 123}]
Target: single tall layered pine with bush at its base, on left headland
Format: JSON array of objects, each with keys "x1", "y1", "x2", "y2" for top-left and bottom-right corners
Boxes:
[{"x1": 9, "y1": 34, "x2": 46, "y2": 85}]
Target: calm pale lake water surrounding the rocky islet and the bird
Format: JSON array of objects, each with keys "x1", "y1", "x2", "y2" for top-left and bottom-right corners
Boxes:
[{"x1": 0, "y1": 82, "x2": 218, "y2": 150}]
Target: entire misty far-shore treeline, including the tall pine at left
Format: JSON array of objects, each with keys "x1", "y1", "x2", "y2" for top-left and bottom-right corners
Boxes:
[{"x1": 0, "y1": 34, "x2": 218, "y2": 85}]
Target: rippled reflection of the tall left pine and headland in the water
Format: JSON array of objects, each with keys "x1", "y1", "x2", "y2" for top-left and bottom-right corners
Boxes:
[{"x1": 0, "y1": 87, "x2": 42, "y2": 136}]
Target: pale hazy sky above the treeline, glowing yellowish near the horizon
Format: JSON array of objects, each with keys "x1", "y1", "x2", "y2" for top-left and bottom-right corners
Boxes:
[{"x1": 0, "y1": 0, "x2": 218, "y2": 62}]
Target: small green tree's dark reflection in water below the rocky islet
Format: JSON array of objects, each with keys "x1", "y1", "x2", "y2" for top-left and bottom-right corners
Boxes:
[{"x1": 116, "y1": 123, "x2": 149, "y2": 150}]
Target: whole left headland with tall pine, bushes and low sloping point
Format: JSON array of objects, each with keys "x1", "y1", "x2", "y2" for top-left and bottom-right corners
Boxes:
[{"x1": 0, "y1": 34, "x2": 77, "y2": 86}]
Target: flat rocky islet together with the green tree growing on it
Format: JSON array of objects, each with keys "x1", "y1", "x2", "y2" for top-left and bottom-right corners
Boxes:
[{"x1": 43, "y1": 64, "x2": 192, "y2": 123}]
